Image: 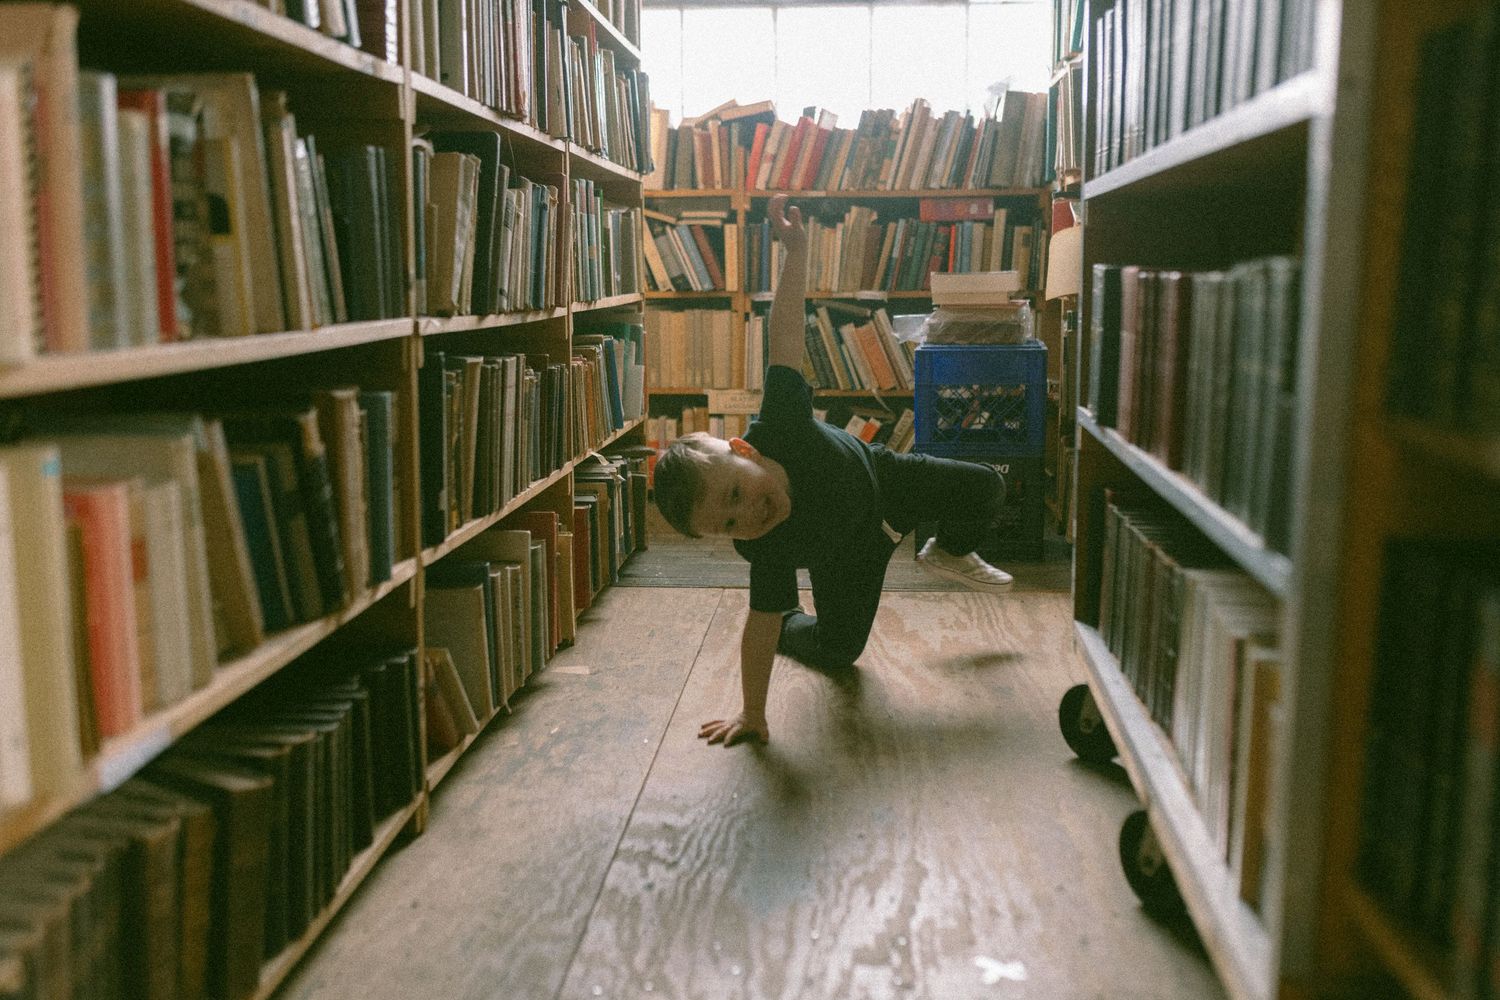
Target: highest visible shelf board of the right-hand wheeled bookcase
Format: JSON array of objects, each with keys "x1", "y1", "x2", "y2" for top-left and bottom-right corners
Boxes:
[{"x1": 1083, "y1": 70, "x2": 1328, "y2": 199}]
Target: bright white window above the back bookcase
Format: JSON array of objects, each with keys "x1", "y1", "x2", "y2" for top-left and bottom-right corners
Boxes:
[{"x1": 642, "y1": 0, "x2": 1052, "y2": 127}]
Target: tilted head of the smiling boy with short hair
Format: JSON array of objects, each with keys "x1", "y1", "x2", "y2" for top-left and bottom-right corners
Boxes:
[{"x1": 656, "y1": 433, "x2": 792, "y2": 540}]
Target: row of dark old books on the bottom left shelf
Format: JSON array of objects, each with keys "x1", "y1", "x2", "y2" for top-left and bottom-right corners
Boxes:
[{"x1": 0, "y1": 651, "x2": 423, "y2": 1000}]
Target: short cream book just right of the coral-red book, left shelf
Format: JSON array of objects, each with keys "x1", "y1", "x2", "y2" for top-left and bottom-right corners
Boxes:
[{"x1": 141, "y1": 480, "x2": 192, "y2": 708}]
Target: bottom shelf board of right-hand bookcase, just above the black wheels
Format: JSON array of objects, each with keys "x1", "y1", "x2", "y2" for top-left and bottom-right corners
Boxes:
[{"x1": 1074, "y1": 622, "x2": 1274, "y2": 1000}]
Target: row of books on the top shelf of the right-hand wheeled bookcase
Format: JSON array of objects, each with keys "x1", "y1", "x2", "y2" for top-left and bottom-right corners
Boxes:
[{"x1": 1091, "y1": 0, "x2": 1317, "y2": 175}]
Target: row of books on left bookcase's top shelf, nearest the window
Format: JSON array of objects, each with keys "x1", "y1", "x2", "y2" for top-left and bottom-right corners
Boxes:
[{"x1": 413, "y1": 0, "x2": 651, "y2": 171}]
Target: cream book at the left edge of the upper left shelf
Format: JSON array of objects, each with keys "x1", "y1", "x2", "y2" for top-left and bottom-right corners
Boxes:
[{"x1": 0, "y1": 61, "x2": 44, "y2": 364}]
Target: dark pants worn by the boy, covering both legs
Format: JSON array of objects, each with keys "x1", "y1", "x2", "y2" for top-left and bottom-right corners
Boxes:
[{"x1": 777, "y1": 447, "x2": 1005, "y2": 669}]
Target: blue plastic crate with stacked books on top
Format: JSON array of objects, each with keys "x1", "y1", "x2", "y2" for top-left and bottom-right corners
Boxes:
[{"x1": 914, "y1": 340, "x2": 1047, "y2": 456}]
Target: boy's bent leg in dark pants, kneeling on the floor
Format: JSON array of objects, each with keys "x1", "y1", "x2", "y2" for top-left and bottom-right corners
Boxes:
[{"x1": 777, "y1": 544, "x2": 894, "y2": 670}]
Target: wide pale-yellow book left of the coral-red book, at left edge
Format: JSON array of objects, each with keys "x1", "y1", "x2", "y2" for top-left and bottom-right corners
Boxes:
[{"x1": 0, "y1": 444, "x2": 83, "y2": 796}]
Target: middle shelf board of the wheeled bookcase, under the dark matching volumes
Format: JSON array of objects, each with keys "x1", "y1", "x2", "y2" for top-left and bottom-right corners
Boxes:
[{"x1": 1077, "y1": 406, "x2": 1292, "y2": 600}]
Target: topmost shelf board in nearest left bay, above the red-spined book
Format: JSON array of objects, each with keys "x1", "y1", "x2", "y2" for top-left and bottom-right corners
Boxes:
[{"x1": 78, "y1": 0, "x2": 405, "y2": 85}]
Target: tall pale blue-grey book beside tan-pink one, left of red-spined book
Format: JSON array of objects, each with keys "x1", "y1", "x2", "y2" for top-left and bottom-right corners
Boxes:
[{"x1": 78, "y1": 70, "x2": 131, "y2": 351}]
